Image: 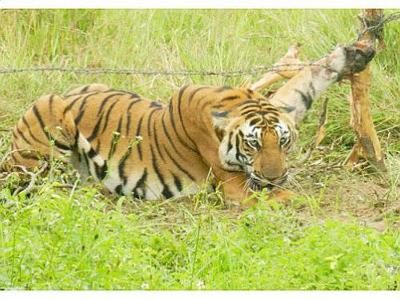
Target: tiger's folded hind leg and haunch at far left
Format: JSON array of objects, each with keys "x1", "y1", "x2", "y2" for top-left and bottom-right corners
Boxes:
[{"x1": 2, "y1": 95, "x2": 78, "y2": 170}]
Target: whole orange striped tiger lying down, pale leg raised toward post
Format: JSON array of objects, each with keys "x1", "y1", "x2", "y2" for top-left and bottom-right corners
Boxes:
[{"x1": 6, "y1": 41, "x2": 376, "y2": 205}]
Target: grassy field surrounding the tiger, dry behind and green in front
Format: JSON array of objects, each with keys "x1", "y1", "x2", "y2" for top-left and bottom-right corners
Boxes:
[{"x1": 0, "y1": 10, "x2": 400, "y2": 290}]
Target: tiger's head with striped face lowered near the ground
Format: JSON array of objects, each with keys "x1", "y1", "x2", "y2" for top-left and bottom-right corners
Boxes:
[{"x1": 213, "y1": 99, "x2": 297, "y2": 191}]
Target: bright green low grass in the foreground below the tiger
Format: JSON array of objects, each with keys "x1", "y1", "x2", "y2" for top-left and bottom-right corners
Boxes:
[{"x1": 0, "y1": 185, "x2": 400, "y2": 290}]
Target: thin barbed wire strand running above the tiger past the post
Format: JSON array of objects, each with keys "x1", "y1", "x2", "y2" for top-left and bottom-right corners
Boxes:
[{"x1": 0, "y1": 12, "x2": 400, "y2": 77}]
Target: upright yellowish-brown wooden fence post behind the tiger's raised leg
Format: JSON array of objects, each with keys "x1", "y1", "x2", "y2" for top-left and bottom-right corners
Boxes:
[{"x1": 345, "y1": 9, "x2": 386, "y2": 171}]
